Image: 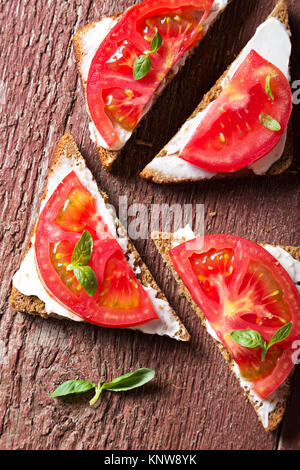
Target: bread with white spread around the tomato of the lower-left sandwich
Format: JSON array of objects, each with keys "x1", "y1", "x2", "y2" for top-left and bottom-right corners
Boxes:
[{"x1": 10, "y1": 134, "x2": 190, "y2": 341}]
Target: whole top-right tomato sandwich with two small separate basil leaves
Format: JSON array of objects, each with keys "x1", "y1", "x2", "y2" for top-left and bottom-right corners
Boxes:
[{"x1": 141, "y1": 0, "x2": 293, "y2": 183}]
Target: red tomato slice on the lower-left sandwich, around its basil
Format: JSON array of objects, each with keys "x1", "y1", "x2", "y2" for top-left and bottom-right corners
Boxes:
[{"x1": 35, "y1": 171, "x2": 158, "y2": 328}]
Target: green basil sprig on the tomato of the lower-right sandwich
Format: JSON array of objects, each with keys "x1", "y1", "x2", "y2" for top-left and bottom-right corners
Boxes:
[{"x1": 230, "y1": 322, "x2": 293, "y2": 362}]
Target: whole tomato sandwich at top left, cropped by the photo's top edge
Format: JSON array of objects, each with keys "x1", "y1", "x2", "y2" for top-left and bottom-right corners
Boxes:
[{"x1": 73, "y1": 0, "x2": 230, "y2": 169}]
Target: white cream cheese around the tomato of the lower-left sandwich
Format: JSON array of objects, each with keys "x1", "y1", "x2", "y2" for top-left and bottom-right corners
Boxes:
[{"x1": 13, "y1": 151, "x2": 182, "y2": 338}]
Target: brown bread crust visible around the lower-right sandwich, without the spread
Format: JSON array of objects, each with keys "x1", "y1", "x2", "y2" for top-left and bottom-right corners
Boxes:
[{"x1": 152, "y1": 232, "x2": 300, "y2": 432}]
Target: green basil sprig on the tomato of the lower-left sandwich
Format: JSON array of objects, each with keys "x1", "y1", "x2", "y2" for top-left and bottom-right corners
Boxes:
[{"x1": 66, "y1": 230, "x2": 98, "y2": 297}]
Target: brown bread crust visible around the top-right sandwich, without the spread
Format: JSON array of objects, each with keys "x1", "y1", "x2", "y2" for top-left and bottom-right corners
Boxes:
[{"x1": 140, "y1": 0, "x2": 293, "y2": 184}]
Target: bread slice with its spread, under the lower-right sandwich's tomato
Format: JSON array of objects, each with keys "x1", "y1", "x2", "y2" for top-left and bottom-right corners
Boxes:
[{"x1": 152, "y1": 232, "x2": 300, "y2": 431}]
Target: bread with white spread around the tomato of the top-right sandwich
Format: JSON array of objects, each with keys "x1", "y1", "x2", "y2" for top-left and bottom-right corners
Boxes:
[{"x1": 140, "y1": 0, "x2": 293, "y2": 184}]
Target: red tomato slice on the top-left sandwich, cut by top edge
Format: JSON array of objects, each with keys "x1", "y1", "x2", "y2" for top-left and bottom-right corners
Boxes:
[{"x1": 87, "y1": 0, "x2": 213, "y2": 147}]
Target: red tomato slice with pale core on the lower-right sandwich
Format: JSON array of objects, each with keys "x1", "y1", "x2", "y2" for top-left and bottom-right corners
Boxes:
[{"x1": 169, "y1": 235, "x2": 300, "y2": 399}]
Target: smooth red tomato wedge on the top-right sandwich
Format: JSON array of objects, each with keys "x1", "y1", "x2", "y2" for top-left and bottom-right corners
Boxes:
[{"x1": 180, "y1": 50, "x2": 292, "y2": 173}]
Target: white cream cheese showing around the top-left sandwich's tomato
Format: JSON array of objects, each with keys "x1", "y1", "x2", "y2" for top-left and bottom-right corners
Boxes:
[{"x1": 79, "y1": 0, "x2": 228, "y2": 150}]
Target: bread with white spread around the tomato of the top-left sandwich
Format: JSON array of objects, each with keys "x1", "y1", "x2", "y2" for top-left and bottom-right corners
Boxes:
[{"x1": 73, "y1": 0, "x2": 231, "y2": 170}]
